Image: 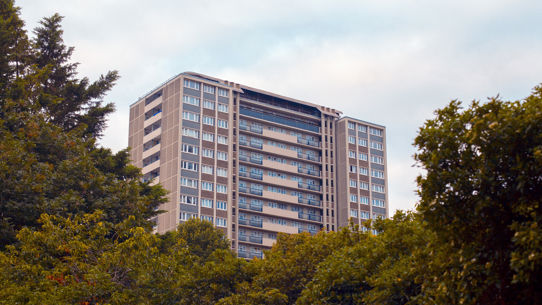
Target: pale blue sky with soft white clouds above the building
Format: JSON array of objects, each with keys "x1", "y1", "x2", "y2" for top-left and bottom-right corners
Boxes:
[{"x1": 16, "y1": 0, "x2": 542, "y2": 215}]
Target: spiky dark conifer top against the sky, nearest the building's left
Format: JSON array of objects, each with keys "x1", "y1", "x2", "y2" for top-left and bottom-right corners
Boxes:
[{"x1": 32, "y1": 14, "x2": 119, "y2": 137}]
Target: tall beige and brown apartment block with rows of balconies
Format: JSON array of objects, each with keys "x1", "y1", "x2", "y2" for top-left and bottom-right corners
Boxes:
[{"x1": 129, "y1": 72, "x2": 388, "y2": 258}]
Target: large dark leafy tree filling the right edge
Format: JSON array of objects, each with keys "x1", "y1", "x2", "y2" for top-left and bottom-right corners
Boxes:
[{"x1": 415, "y1": 87, "x2": 542, "y2": 304}]
